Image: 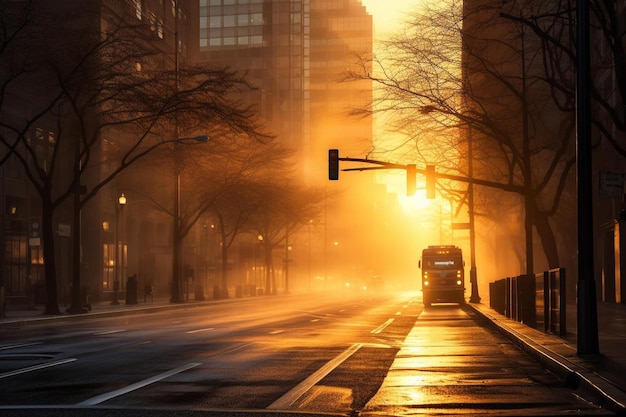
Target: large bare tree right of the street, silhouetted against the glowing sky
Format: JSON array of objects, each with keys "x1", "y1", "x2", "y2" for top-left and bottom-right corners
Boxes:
[{"x1": 342, "y1": 0, "x2": 575, "y2": 272}]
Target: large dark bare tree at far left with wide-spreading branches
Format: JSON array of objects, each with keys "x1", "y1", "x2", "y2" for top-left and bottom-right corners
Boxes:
[{"x1": 0, "y1": 2, "x2": 266, "y2": 314}]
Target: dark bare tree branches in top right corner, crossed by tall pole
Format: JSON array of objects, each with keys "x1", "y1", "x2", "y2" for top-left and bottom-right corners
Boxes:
[{"x1": 501, "y1": 0, "x2": 626, "y2": 156}]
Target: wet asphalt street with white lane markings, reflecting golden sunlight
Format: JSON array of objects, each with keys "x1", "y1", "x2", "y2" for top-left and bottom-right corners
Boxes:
[{"x1": 0, "y1": 292, "x2": 608, "y2": 416}]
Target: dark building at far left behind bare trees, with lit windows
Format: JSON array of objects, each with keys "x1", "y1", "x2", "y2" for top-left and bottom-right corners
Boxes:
[{"x1": 0, "y1": 0, "x2": 197, "y2": 305}]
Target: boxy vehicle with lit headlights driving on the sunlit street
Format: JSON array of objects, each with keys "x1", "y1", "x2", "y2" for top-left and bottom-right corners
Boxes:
[{"x1": 419, "y1": 245, "x2": 465, "y2": 307}]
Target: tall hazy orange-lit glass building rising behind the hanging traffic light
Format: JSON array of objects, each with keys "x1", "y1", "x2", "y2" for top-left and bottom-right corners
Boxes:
[{"x1": 196, "y1": 0, "x2": 372, "y2": 178}]
